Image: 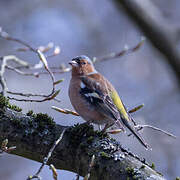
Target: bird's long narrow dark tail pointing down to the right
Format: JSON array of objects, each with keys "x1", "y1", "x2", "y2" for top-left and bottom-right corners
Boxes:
[{"x1": 121, "y1": 116, "x2": 151, "y2": 149}]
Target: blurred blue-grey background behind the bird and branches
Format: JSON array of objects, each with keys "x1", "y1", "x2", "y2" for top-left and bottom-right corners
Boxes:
[{"x1": 0, "y1": 0, "x2": 180, "y2": 180}]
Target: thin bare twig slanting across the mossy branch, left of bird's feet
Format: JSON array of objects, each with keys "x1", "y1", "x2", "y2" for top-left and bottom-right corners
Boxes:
[{"x1": 27, "y1": 129, "x2": 66, "y2": 180}]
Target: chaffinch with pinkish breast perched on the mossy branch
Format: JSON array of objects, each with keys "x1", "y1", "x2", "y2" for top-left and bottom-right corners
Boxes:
[{"x1": 68, "y1": 55, "x2": 149, "y2": 149}]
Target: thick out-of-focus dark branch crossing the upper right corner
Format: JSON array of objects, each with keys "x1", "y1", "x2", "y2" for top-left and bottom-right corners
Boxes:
[{"x1": 114, "y1": 0, "x2": 180, "y2": 84}]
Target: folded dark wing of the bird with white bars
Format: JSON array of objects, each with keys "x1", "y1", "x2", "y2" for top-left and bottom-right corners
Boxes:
[{"x1": 80, "y1": 76, "x2": 120, "y2": 121}]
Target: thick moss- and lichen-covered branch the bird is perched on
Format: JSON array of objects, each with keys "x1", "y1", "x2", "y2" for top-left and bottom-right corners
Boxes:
[{"x1": 0, "y1": 102, "x2": 164, "y2": 180}]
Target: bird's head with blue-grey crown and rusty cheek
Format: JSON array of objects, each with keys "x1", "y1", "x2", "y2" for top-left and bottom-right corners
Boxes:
[{"x1": 69, "y1": 55, "x2": 96, "y2": 76}]
